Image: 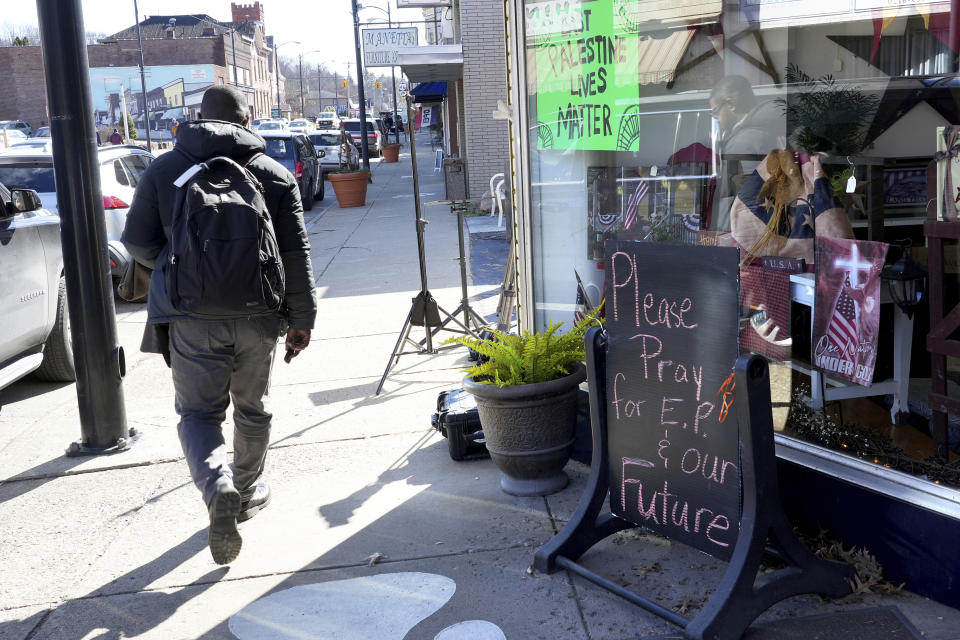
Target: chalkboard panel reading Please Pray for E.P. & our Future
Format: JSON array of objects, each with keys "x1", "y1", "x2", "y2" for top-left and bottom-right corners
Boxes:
[{"x1": 605, "y1": 241, "x2": 740, "y2": 559}]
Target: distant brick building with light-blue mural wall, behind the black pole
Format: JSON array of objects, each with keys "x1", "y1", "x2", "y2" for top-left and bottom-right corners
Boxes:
[{"x1": 0, "y1": 2, "x2": 284, "y2": 138}]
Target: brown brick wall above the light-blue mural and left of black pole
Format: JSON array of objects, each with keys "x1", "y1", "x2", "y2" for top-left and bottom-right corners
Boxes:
[{"x1": 0, "y1": 38, "x2": 225, "y2": 129}]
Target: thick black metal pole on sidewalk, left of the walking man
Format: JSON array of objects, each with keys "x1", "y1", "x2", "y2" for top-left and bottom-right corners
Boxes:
[{"x1": 37, "y1": 0, "x2": 131, "y2": 454}]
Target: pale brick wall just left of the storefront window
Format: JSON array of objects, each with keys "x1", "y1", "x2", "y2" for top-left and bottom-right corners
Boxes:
[{"x1": 460, "y1": 0, "x2": 510, "y2": 202}]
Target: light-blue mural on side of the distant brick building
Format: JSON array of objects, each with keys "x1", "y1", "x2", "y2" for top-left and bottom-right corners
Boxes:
[{"x1": 90, "y1": 64, "x2": 216, "y2": 139}]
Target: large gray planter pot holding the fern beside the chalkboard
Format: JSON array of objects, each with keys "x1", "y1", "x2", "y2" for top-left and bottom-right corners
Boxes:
[{"x1": 463, "y1": 364, "x2": 587, "y2": 496}]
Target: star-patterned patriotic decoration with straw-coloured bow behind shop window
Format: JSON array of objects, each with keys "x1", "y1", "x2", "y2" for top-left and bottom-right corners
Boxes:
[{"x1": 730, "y1": 149, "x2": 853, "y2": 262}]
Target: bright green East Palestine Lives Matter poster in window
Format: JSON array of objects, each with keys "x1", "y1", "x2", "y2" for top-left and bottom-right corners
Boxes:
[{"x1": 528, "y1": 0, "x2": 640, "y2": 151}]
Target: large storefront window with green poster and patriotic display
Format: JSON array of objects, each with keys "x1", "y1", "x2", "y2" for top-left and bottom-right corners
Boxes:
[{"x1": 523, "y1": 0, "x2": 960, "y2": 486}]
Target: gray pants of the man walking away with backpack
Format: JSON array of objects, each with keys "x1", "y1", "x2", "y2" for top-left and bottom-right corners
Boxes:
[{"x1": 170, "y1": 316, "x2": 283, "y2": 506}]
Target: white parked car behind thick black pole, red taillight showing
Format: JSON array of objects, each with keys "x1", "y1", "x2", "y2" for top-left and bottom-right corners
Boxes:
[{"x1": 0, "y1": 140, "x2": 153, "y2": 292}]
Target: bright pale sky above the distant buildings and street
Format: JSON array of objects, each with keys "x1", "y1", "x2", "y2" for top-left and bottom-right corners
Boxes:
[{"x1": 16, "y1": 0, "x2": 425, "y2": 77}]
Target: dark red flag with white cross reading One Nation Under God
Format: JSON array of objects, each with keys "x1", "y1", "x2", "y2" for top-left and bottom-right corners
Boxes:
[{"x1": 813, "y1": 238, "x2": 889, "y2": 387}]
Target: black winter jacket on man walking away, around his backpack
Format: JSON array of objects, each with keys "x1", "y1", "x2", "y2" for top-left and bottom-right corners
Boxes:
[{"x1": 121, "y1": 120, "x2": 317, "y2": 332}]
